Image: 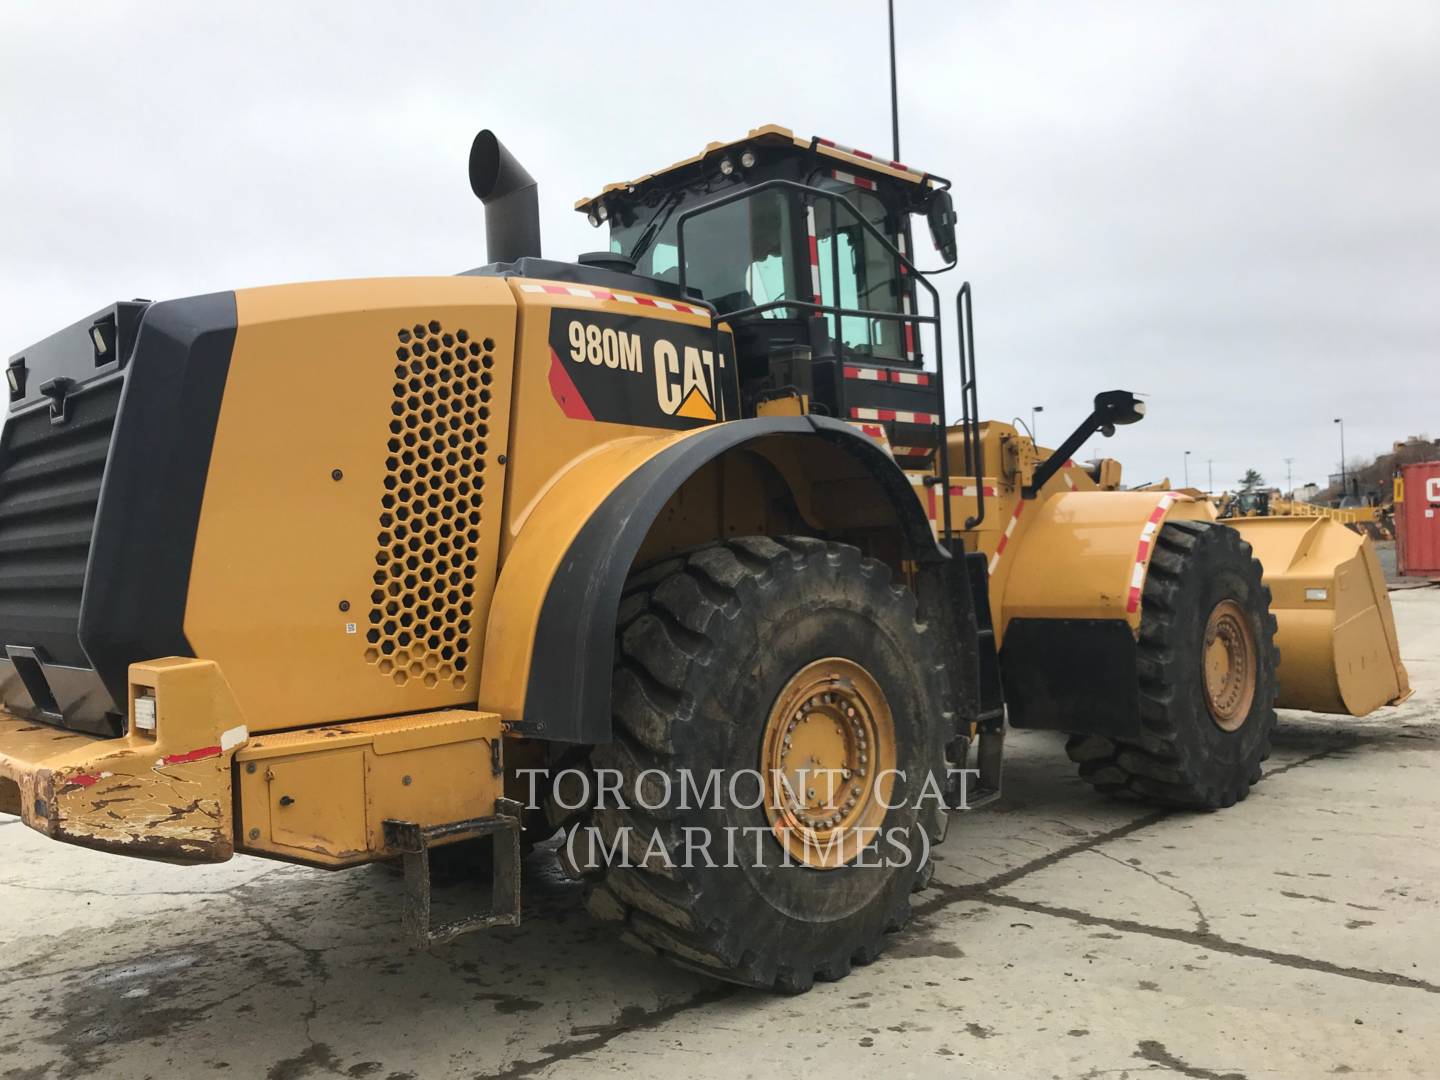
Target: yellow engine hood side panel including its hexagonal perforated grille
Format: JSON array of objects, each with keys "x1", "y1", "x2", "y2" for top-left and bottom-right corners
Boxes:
[{"x1": 184, "y1": 276, "x2": 517, "y2": 733}]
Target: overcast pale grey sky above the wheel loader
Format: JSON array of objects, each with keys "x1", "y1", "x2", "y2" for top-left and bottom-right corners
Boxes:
[{"x1": 0, "y1": 0, "x2": 1440, "y2": 488}]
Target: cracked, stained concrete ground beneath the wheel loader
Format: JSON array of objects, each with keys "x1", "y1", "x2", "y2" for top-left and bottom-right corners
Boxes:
[{"x1": 0, "y1": 589, "x2": 1440, "y2": 1080}]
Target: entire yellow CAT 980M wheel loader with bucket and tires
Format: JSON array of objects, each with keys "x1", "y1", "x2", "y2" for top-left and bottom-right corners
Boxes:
[{"x1": 0, "y1": 127, "x2": 1407, "y2": 991}]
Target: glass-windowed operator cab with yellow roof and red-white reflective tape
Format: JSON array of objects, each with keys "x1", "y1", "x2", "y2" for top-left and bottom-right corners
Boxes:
[{"x1": 576, "y1": 125, "x2": 955, "y2": 464}]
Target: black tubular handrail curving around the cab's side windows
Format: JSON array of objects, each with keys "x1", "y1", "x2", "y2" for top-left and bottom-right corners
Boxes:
[{"x1": 675, "y1": 179, "x2": 952, "y2": 550}]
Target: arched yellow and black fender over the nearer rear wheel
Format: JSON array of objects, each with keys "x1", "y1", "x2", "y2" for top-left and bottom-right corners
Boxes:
[{"x1": 480, "y1": 416, "x2": 938, "y2": 743}]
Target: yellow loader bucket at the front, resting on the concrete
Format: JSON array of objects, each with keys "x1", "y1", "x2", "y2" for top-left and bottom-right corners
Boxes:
[{"x1": 1225, "y1": 517, "x2": 1410, "y2": 716}]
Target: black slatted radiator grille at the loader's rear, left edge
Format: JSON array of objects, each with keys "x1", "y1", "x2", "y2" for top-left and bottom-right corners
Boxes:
[{"x1": 0, "y1": 376, "x2": 124, "y2": 667}]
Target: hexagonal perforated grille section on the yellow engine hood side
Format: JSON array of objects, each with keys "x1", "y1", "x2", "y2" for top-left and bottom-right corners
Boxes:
[{"x1": 364, "y1": 320, "x2": 495, "y2": 688}]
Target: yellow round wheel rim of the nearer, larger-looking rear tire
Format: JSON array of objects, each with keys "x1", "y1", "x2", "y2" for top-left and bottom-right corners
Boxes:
[{"x1": 760, "y1": 657, "x2": 896, "y2": 870}]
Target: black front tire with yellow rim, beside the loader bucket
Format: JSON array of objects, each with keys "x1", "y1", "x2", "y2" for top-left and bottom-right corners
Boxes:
[{"x1": 1066, "y1": 521, "x2": 1280, "y2": 809}]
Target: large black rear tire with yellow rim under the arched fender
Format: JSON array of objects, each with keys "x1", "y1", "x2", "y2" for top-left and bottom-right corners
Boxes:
[{"x1": 588, "y1": 537, "x2": 946, "y2": 992}]
